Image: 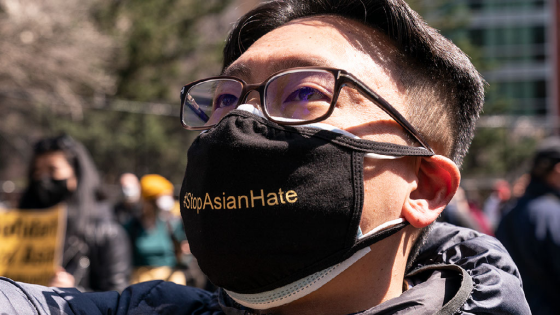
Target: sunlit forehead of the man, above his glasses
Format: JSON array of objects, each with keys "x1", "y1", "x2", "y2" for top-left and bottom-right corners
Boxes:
[{"x1": 224, "y1": 15, "x2": 397, "y2": 88}]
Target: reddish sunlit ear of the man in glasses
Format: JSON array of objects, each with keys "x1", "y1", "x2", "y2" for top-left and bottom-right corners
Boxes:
[{"x1": 402, "y1": 155, "x2": 461, "y2": 228}]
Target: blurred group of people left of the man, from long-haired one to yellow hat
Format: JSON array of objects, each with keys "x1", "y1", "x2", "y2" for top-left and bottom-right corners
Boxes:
[{"x1": 2, "y1": 135, "x2": 211, "y2": 291}]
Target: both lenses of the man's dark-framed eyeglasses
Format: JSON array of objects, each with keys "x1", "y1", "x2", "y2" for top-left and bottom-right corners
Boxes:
[{"x1": 183, "y1": 69, "x2": 336, "y2": 127}]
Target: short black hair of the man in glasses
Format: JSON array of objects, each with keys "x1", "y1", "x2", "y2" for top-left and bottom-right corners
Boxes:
[{"x1": 223, "y1": 0, "x2": 484, "y2": 165}]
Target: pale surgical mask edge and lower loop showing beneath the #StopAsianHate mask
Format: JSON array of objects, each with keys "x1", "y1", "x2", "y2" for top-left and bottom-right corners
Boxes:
[{"x1": 225, "y1": 218, "x2": 404, "y2": 310}]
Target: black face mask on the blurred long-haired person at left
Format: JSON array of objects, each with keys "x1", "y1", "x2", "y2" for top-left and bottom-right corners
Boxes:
[{"x1": 29, "y1": 177, "x2": 70, "y2": 208}]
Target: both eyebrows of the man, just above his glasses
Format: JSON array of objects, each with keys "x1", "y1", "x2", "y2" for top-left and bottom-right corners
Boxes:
[{"x1": 222, "y1": 57, "x2": 332, "y2": 79}]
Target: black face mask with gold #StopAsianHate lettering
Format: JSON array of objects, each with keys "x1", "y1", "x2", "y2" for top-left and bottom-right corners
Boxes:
[{"x1": 180, "y1": 110, "x2": 433, "y2": 294}]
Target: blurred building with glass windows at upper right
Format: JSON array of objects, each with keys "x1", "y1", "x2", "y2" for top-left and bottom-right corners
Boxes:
[{"x1": 460, "y1": 0, "x2": 559, "y2": 121}]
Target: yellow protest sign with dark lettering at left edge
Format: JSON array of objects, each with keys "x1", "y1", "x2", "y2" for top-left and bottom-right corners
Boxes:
[{"x1": 0, "y1": 206, "x2": 66, "y2": 285}]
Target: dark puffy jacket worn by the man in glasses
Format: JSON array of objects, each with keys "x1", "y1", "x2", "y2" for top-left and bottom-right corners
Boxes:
[{"x1": 0, "y1": 223, "x2": 530, "y2": 315}]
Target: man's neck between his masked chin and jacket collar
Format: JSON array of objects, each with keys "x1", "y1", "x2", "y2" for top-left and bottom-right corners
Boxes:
[{"x1": 261, "y1": 232, "x2": 410, "y2": 315}]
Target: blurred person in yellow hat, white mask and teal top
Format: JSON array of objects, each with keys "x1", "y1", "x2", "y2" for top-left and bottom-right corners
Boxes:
[{"x1": 125, "y1": 174, "x2": 186, "y2": 284}]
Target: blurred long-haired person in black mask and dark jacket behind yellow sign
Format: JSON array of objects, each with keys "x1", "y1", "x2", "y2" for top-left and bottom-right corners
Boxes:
[{"x1": 19, "y1": 136, "x2": 130, "y2": 291}]
